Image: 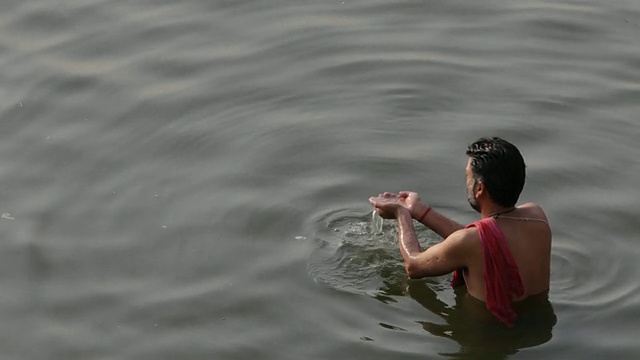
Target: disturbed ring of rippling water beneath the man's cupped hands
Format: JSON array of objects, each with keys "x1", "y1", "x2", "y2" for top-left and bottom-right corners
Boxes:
[{"x1": 308, "y1": 209, "x2": 439, "y2": 302}]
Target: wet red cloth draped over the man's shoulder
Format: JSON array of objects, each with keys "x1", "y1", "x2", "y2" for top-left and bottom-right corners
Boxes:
[{"x1": 451, "y1": 217, "x2": 524, "y2": 327}]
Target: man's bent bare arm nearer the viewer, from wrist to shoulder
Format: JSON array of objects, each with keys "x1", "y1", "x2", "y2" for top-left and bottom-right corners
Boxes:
[{"x1": 396, "y1": 209, "x2": 469, "y2": 279}]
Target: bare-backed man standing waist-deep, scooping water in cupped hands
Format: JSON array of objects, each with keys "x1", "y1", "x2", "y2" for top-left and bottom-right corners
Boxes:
[{"x1": 369, "y1": 137, "x2": 551, "y2": 326}]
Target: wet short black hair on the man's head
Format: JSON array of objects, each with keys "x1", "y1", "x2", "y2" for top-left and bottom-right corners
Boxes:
[{"x1": 467, "y1": 137, "x2": 526, "y2": 207}]
